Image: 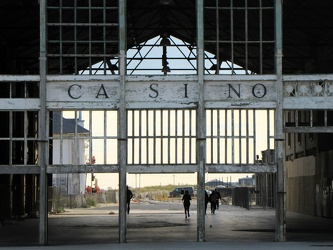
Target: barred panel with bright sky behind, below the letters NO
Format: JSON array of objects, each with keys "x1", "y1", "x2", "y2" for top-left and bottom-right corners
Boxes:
[{"x1": 206, "y1": 109, "x2": 274, "y2": 165}]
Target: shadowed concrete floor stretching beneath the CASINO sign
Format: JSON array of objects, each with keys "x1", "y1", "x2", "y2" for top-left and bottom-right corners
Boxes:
[{"x1": 0, "y1": 200, "x2": 333, "y2": 249}]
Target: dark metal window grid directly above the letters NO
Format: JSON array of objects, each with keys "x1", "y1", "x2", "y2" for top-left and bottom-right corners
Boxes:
[{"x1": 204, "y1": 0, "x2": 275, "y2": 74}]
